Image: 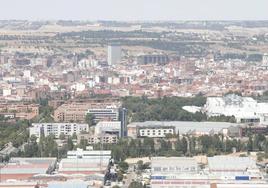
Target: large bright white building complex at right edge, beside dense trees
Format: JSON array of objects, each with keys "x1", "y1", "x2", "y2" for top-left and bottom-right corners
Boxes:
[{"x1": 203, "y1": 94, "x2": 268, "y2": 124}]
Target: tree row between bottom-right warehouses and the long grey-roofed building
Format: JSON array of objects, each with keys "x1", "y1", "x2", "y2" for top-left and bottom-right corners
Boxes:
[{"x1": 90, "y1": 131, "x2": 268, "y2": 161}]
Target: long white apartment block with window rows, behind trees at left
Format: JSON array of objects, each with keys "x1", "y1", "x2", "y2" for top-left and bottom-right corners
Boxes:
[{"x1": 30, "y1": 123, "x2": 89, "y2": 138}]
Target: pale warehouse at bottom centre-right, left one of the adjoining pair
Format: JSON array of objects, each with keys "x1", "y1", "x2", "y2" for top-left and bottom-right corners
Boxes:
[{"x1": 151, "y1": 157, "x2": 210, "y2": 188}]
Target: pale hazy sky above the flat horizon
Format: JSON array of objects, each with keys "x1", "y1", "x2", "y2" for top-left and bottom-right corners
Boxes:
[{"x1": 0, "y1": 0, "x2": 268, "y2": 20}]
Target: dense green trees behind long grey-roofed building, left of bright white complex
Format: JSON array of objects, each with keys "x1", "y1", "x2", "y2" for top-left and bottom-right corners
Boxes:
[{"x1": 122, "y1": 95, "x2": 235, "y2": 122}]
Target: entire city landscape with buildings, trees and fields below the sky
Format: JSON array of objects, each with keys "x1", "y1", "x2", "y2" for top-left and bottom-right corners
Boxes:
[{"x1": 0, "y1": 15, "x2": 268, "y2": 188}]
